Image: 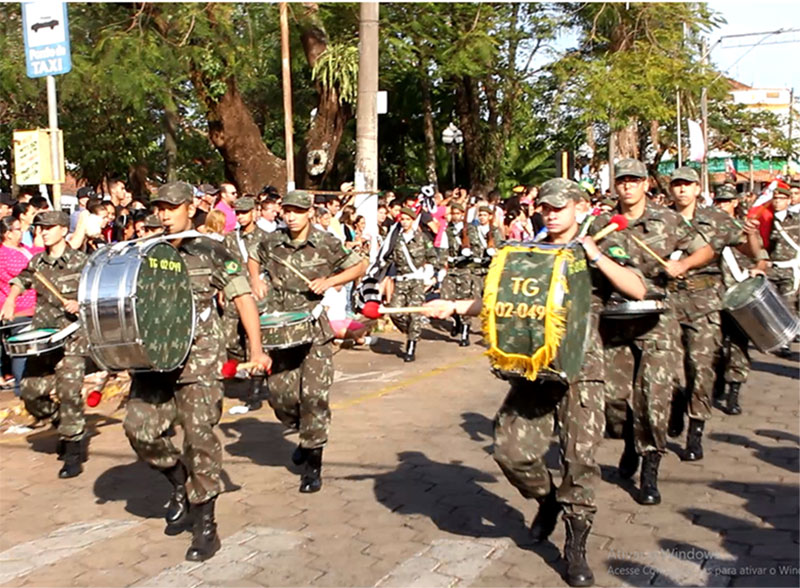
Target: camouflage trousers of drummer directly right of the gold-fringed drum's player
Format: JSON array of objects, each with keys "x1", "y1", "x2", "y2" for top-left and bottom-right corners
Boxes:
[{"x1": 604, "y1": 339, "x2": 678, "y2": 455}]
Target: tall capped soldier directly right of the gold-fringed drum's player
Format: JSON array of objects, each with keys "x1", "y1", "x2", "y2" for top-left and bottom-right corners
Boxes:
[{"x1": 595, "y1": 159, "x2": 713, "y2": 505}]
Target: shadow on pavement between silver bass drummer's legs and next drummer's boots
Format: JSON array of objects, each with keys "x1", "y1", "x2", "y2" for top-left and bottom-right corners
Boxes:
[{"x1": 219, "y1": 417, "x2": 300, "y2": 473}]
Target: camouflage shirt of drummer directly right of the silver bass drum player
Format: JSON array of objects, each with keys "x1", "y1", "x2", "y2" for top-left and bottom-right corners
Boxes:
[{"x1": 248, "y1": 226, "x2": 361, "y2": 344}]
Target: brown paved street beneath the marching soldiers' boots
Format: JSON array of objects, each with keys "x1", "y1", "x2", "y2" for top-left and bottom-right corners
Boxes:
[{"x1": 0, "y1": 330, "x2": 800, "y2": 587}]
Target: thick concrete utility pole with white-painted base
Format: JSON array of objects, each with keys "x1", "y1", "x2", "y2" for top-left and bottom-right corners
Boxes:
[{"x1": 354, "y1": 2, "x2": 379, "y2": 248}]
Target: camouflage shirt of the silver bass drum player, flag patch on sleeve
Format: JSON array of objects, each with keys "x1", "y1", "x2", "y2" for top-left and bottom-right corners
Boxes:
[{"x1": 178, "y1": 237, "x2": 250, "y2": 383}]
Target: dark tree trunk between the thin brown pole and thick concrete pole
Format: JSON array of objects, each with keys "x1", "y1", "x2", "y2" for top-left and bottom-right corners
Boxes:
[{"x1": 295, "y1": 2, "x2": 353, "y2": 188}]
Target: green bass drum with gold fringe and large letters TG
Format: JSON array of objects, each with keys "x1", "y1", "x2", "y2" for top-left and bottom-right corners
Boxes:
[{"x1": 481, "y1": 244, "x2": 592, "y2": 380}]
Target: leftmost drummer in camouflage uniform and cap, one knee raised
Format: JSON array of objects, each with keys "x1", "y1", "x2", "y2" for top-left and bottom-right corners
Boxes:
[{"x1": 2, "y1": 210, "x2": 88, "y2": 478}]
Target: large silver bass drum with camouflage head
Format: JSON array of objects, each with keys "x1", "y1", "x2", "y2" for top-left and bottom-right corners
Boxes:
[{"x1": 78, "y1": 240, "x2": 195, "y2": 372}]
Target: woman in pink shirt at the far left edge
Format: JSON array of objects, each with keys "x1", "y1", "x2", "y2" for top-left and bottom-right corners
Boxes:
[{"x1": 0, "y1": 216, "x2": 43, "y2": 396}]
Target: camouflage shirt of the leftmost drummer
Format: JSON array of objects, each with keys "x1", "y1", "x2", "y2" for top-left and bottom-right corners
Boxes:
[{"x1": 9, "y1": 245, "x2": 88, "y2": 355}]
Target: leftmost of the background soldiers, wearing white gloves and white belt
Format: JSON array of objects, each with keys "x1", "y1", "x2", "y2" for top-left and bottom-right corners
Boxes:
[{"x1": 389, "y1": 207, "x2": 439, "y2": 362}]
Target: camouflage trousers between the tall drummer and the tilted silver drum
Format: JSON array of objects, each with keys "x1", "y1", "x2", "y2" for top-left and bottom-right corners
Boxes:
[{"x1": 681, "y1": 312, "x2": 722, "y2": 421}]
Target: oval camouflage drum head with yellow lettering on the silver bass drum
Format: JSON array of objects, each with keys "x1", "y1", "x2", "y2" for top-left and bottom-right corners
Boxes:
[{"x1": 136, "y1": 242, "x2": 194, "y2": 371}]
